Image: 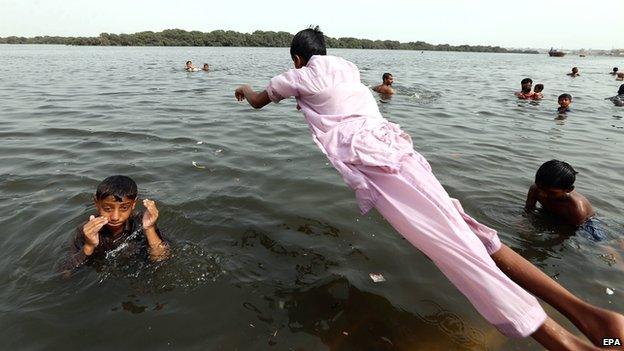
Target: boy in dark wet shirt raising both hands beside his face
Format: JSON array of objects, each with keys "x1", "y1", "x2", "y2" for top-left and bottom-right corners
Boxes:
[{"x1": 66, "y1": 175, "x2": 169, "y2": 269}]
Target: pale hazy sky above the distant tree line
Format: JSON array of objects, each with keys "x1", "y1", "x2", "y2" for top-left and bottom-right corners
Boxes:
[{"x1": 0, "y1": 0, "x2": 624, "y2": 49}]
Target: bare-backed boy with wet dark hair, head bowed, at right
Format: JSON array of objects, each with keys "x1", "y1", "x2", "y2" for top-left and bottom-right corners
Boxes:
[{"x1": 524, "y1": 160, "x2": 606, "y2": 241}]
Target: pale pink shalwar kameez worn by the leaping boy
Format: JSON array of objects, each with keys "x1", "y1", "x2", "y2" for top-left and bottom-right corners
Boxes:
[{"x1": 266, "y1": 56, "x2": 546, "y2": 337}]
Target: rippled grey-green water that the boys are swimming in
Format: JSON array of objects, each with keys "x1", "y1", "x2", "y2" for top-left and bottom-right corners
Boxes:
[{"x1": 0, "y1": 45, "x2": 624, "y2": 350}]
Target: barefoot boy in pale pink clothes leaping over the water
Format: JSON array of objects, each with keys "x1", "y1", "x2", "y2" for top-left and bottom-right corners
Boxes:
[{"x1": 235, "y1": 28, "x2": 624, "y2": 350}]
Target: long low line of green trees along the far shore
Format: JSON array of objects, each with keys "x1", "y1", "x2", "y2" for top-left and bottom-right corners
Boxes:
[{"x1": 0, "y1": 29, "x2": 538, "y2": 54}]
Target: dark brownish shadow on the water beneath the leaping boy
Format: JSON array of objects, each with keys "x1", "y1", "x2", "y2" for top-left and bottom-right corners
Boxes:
[{"x1": 277, "y1": 276, "x2": 487, "y2": 350}]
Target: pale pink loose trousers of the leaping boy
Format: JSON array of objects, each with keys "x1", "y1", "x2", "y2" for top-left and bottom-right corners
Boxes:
[{"x1": 358, "y1": 154, "x2": 547, "y2": 337}]
